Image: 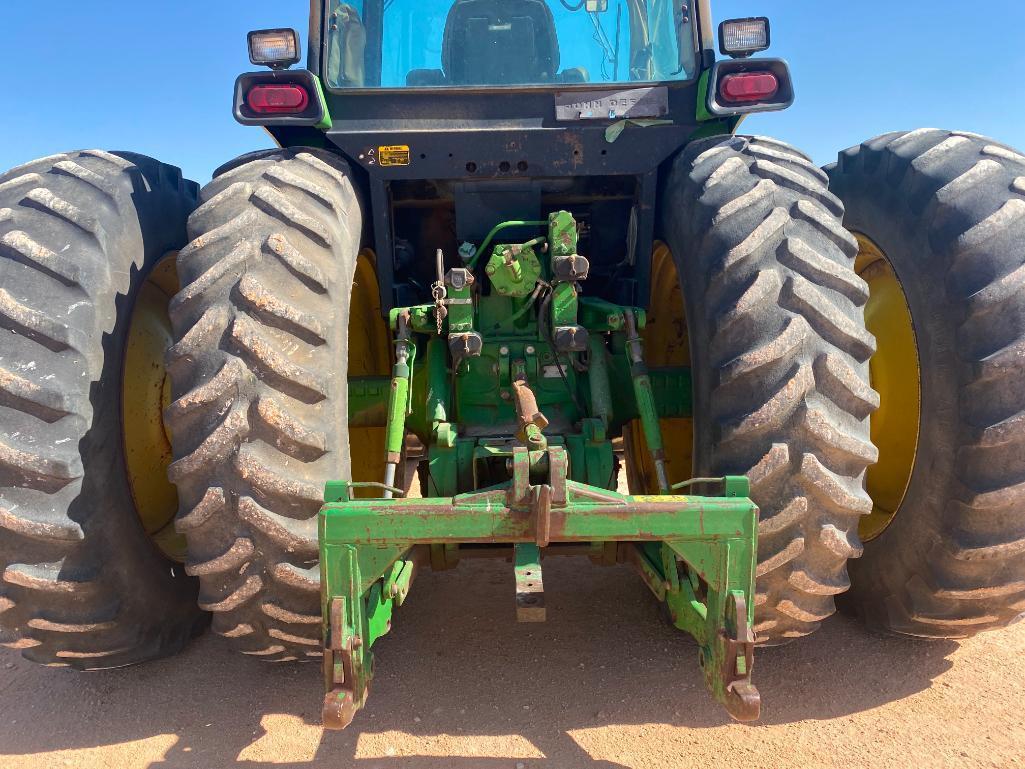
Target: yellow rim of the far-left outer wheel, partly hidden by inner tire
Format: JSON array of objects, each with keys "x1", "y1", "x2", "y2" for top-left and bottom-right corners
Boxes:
[{"x1": 121, "y1": 253, "x2": 186, "y2": 562}]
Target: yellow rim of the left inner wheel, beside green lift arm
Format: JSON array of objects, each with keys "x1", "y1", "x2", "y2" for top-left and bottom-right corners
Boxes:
[{"x1": 349, "y1": 249, "x2": 392, "y2": 496}]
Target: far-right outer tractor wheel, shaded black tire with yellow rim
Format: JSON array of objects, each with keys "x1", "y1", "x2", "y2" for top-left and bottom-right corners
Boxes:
[{"x1": 827, "y1": 129, "x2": 1025, "y2": 638}]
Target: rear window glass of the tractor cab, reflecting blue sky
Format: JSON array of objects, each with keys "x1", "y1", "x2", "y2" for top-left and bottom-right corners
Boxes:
[{"x1": 324, "y1": 0, "x2": 697, "y2": 88}]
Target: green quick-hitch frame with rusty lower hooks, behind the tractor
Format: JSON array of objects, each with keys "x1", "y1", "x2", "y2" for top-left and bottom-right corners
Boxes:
[{"x1": 320, "y1": 455, "x2": 761, "y2": 729}]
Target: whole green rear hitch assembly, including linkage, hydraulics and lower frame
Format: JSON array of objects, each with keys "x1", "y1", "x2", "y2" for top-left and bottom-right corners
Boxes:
[{"x1": 320, "y1": 211, "x2": 759, "y2": 727}]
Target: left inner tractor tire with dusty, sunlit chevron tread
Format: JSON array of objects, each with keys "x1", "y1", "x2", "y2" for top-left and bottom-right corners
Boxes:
[{"x1": 167, "y1": 150, "x2": 364, "y2": 661}]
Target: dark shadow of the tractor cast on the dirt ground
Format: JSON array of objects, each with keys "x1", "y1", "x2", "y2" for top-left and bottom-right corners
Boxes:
[{"x1": 0, "y1": 558, "x2": 957, "y2": 769}]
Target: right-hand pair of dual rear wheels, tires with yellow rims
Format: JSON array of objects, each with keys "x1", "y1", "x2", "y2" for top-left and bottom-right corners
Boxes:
[{"x1": 633, "y1": 129, "x2": 1025, "y2": 644}]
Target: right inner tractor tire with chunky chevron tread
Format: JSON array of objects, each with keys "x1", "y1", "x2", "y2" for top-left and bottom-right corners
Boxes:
[{"x1": 656, "y1": 136, "x2": 877, "y2": 644}]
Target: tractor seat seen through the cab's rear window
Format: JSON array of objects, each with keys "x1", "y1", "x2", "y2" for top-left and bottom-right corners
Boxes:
[{"x1": 406, "y1": 0, "x2": 585, "y2": 86}]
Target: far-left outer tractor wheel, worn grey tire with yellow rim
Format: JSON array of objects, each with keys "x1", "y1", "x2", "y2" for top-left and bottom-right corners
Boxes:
[{"x1": 0, "y1": 152, "x2": 204, "y2": 669}]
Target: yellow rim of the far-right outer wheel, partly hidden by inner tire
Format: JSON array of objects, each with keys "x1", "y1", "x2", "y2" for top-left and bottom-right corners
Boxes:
[{"x1": 855, "y1": 234, "x2": 921, "y2": 541}]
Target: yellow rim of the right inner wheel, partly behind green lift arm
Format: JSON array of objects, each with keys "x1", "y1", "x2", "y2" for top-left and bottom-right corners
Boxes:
[{"x1": 623, "y1": 243, "x2": 694, "y2": 493}]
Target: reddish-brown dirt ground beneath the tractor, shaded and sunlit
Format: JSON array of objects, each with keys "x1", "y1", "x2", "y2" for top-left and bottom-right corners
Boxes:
[{"x1": 0, "y1": 558, "x2": 1025, "y2": 769}]
